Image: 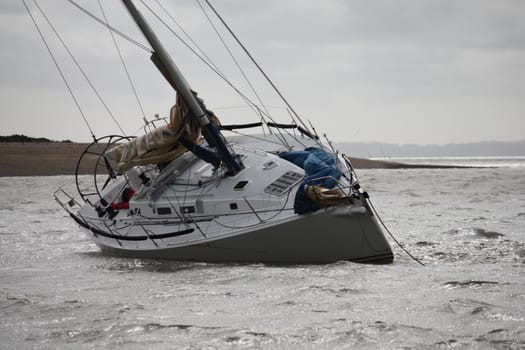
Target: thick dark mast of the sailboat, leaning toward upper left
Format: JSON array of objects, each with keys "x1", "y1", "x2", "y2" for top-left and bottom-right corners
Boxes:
[{"x1": 122, "y1": 0, "x2": 243, "y2": 175}]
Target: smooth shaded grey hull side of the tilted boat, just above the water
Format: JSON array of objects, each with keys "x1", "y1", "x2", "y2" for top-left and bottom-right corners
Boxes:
[{"x1": 74, "y1": 202, "x2": 393, "y2": 264}]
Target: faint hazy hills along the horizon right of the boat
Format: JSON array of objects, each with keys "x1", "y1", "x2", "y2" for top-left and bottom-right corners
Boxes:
[{"x1": 337, "y1": 140, "x2": 525, "y2": 158}]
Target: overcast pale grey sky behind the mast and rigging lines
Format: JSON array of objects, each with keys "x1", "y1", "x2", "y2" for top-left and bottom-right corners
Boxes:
[{"x1": 0, "y1": 0, "x2": 525, "y2": 144}]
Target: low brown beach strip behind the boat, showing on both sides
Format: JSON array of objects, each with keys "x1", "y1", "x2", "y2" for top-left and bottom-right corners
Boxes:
[{"x1": 0, "y1": 142, "x2": 463, "y2": 177}]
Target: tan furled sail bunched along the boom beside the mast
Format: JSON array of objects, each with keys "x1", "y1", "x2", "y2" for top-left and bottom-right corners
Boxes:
[{"x1": 105, "y1": 95, "x2": 219, "y2": 171}]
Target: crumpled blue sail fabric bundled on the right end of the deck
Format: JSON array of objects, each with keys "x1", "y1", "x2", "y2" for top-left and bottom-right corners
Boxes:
[{"x1": 279, "y1": 147, "x2": 341, "y2": 214}]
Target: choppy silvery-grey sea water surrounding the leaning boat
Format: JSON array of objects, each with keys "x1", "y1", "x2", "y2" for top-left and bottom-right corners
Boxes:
[{"x1": 0, "y1": 159, "x2": 525, "y2": 349}]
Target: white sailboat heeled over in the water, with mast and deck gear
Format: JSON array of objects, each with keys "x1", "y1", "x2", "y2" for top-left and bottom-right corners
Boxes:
[{"x1": 50, "y1": 0, "x2": 393, "y2": 264}]
